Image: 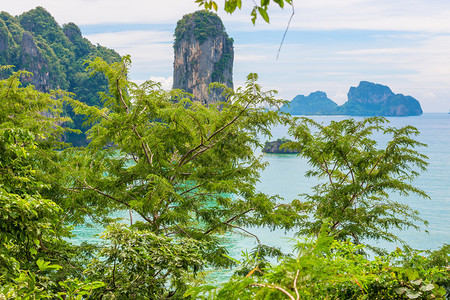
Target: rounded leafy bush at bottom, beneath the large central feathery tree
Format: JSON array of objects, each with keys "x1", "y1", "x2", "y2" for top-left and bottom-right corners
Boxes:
[{"x1": 85, "y1": 224, "x2": 205, "y2": 299}]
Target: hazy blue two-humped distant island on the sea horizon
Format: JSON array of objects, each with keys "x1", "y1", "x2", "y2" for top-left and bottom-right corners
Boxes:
[{"x1": 280, "y1": 81, "x2": 423, "y2": 116}]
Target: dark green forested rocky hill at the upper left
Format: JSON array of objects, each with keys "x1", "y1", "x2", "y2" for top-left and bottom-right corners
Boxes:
[{"x1": 0, "y1": 7, "x2": 120, "y2": 146}]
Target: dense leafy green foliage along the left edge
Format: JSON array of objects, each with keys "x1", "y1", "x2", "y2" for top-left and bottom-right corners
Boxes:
[{"x1": 0, "y1": 67, "x2": 101, "y2": 299}]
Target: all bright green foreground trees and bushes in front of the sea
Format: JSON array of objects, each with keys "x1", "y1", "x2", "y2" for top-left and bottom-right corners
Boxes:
[{"x1": 0, "y1": 57, "x2": 450, "y2": 299}]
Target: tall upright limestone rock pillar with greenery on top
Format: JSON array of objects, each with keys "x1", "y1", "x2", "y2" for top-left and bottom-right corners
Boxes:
[{"x1": 173, "y1": 11, "x2": 234, "y2": 104}]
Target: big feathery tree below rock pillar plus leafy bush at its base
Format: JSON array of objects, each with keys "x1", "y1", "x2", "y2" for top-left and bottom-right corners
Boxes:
[{"x1": 49, "y1": 57, "x2": 302, "y2": 298}]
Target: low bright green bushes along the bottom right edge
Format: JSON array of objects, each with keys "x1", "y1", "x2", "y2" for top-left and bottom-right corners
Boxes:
[{"x1": 195, "y1": 224, "x2": 450, "y2": 300}]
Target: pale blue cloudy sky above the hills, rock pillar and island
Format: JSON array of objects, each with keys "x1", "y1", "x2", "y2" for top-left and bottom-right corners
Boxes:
[{"x1": 0, "y1": 0, "x2": 450, "y2": 112}]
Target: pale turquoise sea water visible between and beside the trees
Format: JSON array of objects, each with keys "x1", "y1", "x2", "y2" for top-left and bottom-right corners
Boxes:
[{"x1": 75, "y1": 114, "x2": 450, "y2": 257}]
